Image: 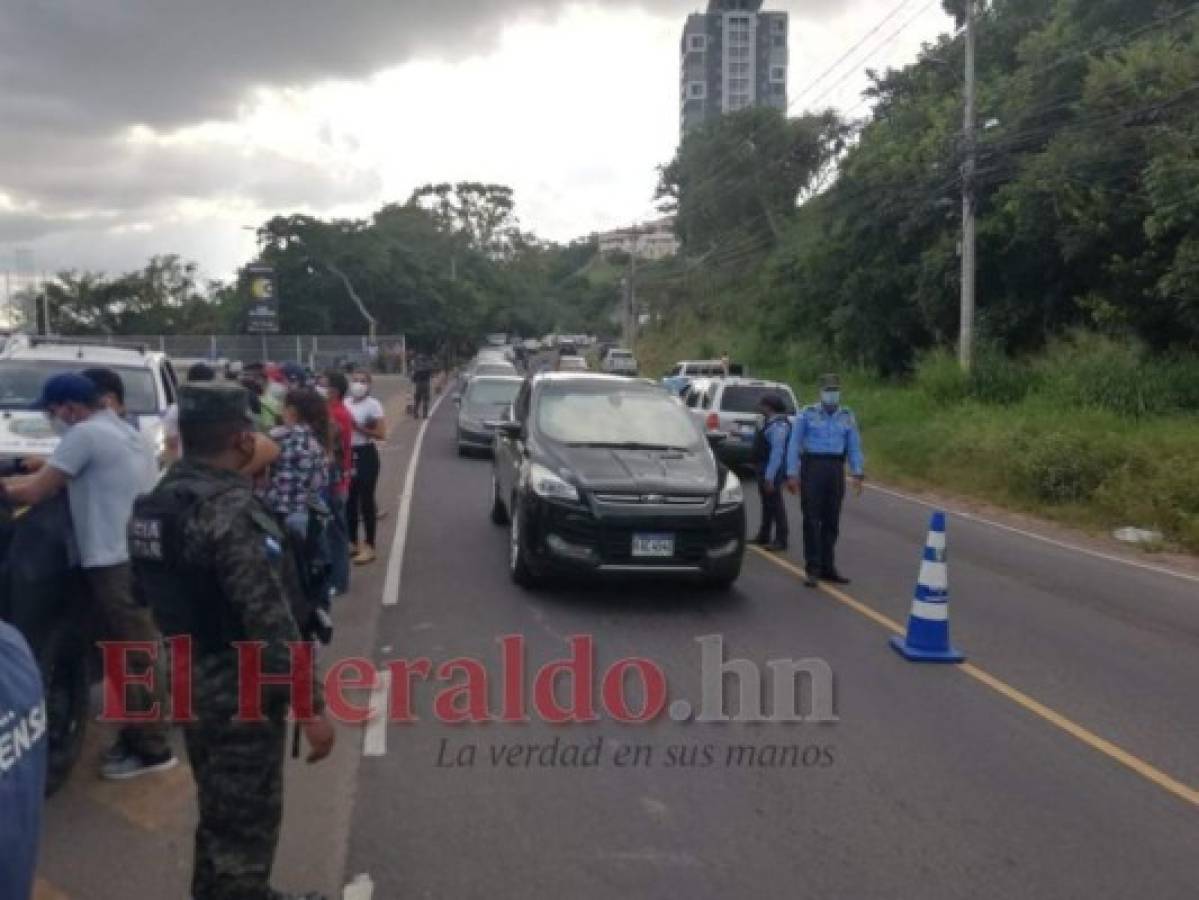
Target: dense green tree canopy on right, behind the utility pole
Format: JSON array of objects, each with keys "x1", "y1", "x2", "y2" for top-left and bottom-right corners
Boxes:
[{"x1": 647, "y1": 0, "x2": 1199, "y2": 372}]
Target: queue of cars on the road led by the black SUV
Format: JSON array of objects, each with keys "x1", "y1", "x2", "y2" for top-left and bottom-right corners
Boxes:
[{"x1": 457, "y1": 350, "x2": 797, "y2": 587}]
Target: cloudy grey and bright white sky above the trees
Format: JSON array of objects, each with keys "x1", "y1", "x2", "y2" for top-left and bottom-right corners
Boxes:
[{"x1": 0, "y1": 0, "x2": 951, "y2": 277}]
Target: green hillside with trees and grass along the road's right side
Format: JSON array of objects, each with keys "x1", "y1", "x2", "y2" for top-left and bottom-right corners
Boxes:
[{"x1": 638, "y1": 0, "x2": 1199, "y2": 550}]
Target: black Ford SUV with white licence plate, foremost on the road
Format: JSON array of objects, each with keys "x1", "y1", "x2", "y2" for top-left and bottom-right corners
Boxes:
[{"x1": 492, "y1": 373, "x2": 746, "y2": 587}]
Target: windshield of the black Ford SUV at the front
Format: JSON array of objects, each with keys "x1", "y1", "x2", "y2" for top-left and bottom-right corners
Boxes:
[{"x1": 536, "y1": 382, "x2": 701, "y2": 449}]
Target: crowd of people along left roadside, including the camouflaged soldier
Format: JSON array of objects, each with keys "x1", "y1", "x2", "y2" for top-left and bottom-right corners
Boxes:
[{"x1": 0, "y1": 363, "x2": 407, "y2": 900}]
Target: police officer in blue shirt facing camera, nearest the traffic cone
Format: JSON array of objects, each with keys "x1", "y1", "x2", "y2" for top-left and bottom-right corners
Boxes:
[{"x1": 787, "y1": 375, "x2": 866, "y2": 587}]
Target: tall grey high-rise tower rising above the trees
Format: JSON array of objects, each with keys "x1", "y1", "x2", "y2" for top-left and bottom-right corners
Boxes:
[{"x1": 679, "y1": 0, "x2": 789, "y2": 137}]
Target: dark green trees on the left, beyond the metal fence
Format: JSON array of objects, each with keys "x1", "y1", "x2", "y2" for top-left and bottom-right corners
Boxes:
[{"x1": 29, "y1": 182, "x2": 620, "y2": 350}]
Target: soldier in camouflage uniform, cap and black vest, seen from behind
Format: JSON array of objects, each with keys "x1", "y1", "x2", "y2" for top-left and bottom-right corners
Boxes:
[{"x1": 129, "y1": 385, "x2": 333, "y2": 900}]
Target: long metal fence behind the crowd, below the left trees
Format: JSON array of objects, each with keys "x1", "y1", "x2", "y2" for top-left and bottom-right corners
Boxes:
[{"x1": 80, "y1": 334, "x2": 408, "y2": 372}]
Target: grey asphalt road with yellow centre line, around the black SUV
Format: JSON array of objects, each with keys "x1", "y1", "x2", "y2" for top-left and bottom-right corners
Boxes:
[{"x1": 347, "y1": 397, "x2": 1199, "y2": 900}]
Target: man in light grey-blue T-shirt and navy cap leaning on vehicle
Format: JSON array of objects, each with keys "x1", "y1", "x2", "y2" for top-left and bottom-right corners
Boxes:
[{"x1": 0, "y1": 373, "x2": 177, "y2": 779}]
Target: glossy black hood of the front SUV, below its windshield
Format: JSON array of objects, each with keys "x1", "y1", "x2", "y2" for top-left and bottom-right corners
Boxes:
[{"x1": 555, "y1": 447, "x2": 717, "y2": 495}]
